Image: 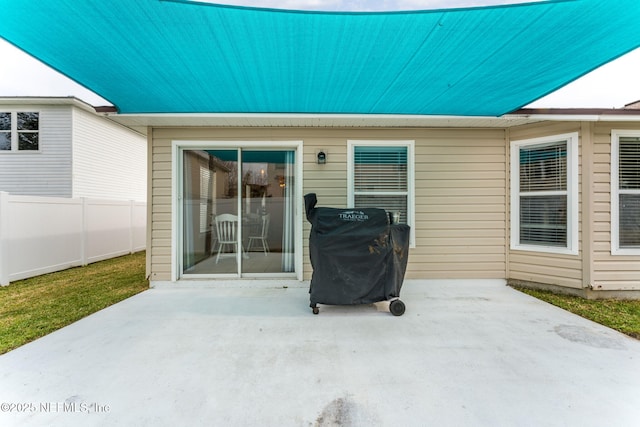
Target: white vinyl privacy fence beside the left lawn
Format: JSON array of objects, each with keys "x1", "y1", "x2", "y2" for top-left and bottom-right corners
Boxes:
[{"x1": 0, "y1": 191, "x2": 147, "y2": 285}]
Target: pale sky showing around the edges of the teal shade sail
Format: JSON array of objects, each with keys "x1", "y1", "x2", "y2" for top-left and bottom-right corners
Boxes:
[{"x1": 0, "y1": 0, "x2": 640, "y2": 108}]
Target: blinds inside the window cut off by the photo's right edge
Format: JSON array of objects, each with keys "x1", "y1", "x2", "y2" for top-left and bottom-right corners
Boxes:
[{"x1": 618, "y1": 137, "x2": 640, "y2": 248}]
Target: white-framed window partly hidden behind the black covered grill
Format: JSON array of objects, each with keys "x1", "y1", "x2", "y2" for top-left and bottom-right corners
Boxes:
[{"x1": 348, "y1": 141, "x2": 415, "y2": 247}]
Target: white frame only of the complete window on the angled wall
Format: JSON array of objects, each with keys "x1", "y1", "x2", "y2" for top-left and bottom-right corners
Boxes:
[{"x1": 511, "y1": 132, "x2": 579, "y2": 255}]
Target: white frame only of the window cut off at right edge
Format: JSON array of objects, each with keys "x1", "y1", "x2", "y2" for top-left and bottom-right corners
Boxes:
[{"x1": 611, "y1": 129, "x2": 640, "y2": 255}]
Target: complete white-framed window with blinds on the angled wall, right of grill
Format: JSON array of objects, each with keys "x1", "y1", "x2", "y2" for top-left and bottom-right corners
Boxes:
[{"x1": 511, "y1": 134, "x2": 578, "y2": 255}]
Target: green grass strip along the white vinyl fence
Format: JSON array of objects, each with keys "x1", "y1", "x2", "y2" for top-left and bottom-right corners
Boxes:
[{"x1": 0, "y1": 252, "x2": 149, "y2": 354}]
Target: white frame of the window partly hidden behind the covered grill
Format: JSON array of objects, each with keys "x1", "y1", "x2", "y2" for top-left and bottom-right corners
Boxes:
[{"x1": 347, "y1": 140, "x2": 416, "y2": 248}]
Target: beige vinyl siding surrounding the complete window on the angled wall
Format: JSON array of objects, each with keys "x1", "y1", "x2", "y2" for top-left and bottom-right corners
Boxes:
[{"x1": 507, "y1": 122, "x2": 584, "y2": 289}]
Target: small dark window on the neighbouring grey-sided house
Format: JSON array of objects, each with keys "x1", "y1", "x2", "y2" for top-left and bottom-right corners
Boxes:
[{"x1": 0, "y1": 112, "x2": 40, "y2": 152}]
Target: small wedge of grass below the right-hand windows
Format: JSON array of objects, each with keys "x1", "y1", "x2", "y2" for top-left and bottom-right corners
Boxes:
[{"x1": 515, "y1": 287, "x2": 640, "y2": 339}]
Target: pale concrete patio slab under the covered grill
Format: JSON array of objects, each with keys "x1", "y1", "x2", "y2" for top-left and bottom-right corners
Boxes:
[{"x1": 0, "y1": 280, "x2": 640, "y2": 427}]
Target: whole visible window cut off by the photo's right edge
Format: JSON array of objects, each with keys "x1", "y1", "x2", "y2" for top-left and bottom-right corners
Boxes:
[{"x1": 611, "y1": 130, "x2": 640, "y2": 255}]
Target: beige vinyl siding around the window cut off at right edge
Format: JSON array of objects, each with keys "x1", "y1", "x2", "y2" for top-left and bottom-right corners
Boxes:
[{"x1": 592, "y1": 123, "x2": 640, "y2": 290}]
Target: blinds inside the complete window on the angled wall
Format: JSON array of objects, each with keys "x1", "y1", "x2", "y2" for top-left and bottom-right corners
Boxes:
[{"x1": 519, "y1": 141, "x2": 568, "y2": 247}]
